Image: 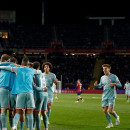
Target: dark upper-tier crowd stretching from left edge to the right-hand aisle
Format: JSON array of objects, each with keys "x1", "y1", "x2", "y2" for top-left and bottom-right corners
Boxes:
[{"x1": 0, "y1": 23, "x2": 103, "y2": 49}]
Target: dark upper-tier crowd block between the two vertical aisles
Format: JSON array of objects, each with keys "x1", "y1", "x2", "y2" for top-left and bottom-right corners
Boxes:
[{"x1": 57, "y1": 24, "x2": 103, "y2": 49}]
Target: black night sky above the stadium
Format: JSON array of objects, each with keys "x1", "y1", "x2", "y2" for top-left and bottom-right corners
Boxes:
[{"x1": 0, "y1": 0, "x2": 130, "y2": 24}]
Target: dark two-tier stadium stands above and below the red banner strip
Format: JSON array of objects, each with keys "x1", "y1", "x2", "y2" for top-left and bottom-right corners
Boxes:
[{"x1": 0, "y1": 22, "x2": 130, "y2": 90}]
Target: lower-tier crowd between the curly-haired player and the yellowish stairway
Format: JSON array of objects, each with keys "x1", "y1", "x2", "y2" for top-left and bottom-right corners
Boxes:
[{"x1": 49, "y1": 55, "x2": 96, "y2": 84}]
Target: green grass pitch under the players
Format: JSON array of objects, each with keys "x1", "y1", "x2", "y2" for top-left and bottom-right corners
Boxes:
[{"x1": 8, "y1": 94, "x2": 130, "y2": 130}]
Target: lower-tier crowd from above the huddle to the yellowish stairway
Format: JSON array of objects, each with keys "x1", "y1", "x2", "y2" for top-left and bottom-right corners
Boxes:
[{"x1": 4, "y1": 54, "x2": 96, "y2": 88}]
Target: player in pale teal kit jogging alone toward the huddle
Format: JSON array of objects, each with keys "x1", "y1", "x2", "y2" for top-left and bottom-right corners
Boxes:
[{"x1": 94, "y1": 64, "x2": 122, "y2": 128}]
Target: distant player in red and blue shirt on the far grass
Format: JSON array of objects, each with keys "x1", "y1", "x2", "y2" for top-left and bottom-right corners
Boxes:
[{"x1": 76, "y1": 79, "x2": 84, "y2": 103}]
